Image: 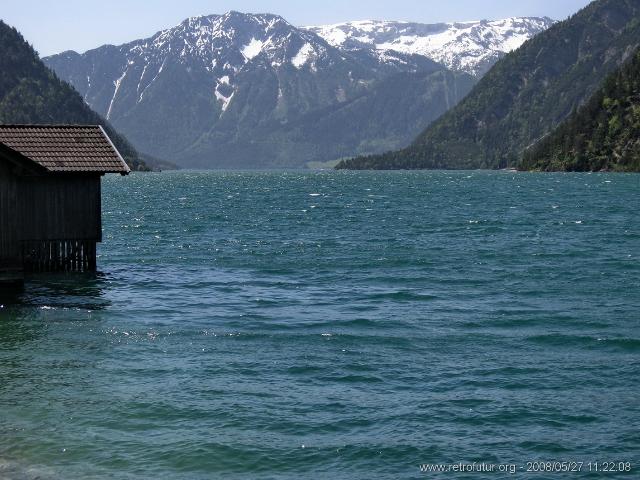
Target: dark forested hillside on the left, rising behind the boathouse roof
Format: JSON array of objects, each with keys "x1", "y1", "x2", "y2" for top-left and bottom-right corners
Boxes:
[{"x1": 0, "y1": 20, "x2": 148, "y2": 170}]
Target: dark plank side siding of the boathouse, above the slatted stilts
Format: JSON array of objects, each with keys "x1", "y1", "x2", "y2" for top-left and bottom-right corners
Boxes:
[{"x1": 18, "y1": 175, "x2": 102, "y2": 242}]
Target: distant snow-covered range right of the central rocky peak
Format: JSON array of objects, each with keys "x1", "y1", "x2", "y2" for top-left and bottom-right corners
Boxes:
[{"x1": 306, "y1": 17, "x2": 554, "y2": 77}]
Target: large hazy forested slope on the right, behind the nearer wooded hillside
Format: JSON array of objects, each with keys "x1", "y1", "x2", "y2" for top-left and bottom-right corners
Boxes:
[{"x1": 339, "y1": 0, "x2": 640, "y2": 169}]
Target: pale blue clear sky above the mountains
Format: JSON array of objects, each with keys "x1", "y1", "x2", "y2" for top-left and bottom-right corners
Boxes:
[{"x1": 0, "y1": 0, "x2": 589, "y2": 56}]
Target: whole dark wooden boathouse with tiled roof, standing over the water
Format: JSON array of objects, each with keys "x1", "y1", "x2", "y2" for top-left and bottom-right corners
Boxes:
[{"x1": 0, "y1": 125, "x2": 129, "y2": 283}]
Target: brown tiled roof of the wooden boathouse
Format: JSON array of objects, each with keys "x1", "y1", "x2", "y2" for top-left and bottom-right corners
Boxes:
[{"x1": 0, "y1": 125, "x2": 129, "y2": 174}]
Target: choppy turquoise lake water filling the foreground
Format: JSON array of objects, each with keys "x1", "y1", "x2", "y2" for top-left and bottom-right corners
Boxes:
[{"x1": 0, "y1": 172, "x2": 640, "y2": 480}]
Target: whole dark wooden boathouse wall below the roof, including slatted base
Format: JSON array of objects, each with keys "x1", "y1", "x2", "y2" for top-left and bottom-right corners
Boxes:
[{"x1": 0, "y1": 160, "x2": 102, "y2": 272}]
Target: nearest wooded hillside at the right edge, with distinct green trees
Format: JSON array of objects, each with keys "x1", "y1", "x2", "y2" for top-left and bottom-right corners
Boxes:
[{"x1": 521, "y1": 49, "x2": 640, "y2": 172}]
